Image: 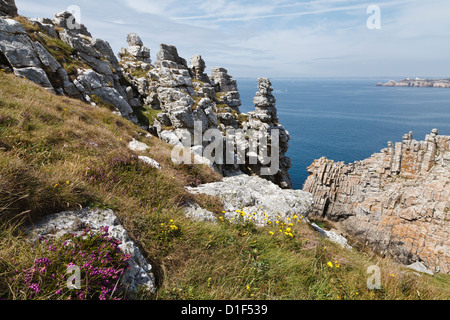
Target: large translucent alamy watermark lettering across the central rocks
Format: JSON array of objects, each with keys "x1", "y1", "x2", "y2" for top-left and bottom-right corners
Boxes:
[{"x1": 172, "y1": 121, "x2": 280, "y2": 176}]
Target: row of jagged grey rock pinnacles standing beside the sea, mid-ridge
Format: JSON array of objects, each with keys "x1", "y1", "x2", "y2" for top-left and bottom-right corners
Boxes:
[{"x1": 120, "y1": 35, "x2": 292, "y2": 188}]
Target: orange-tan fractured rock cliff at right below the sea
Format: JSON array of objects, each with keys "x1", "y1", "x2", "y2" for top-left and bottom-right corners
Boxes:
[{"x1": 303, "y1": 129, "x2": 450, "y2": 273}]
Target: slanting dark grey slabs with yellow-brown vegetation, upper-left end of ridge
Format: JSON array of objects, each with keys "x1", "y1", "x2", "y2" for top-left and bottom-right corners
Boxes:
[{"x1": 0, "y1": 12, "x2": 137, "y2": 122}]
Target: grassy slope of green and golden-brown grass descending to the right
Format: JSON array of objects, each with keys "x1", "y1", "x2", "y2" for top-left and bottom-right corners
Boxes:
[{"x1": 0, "y1": 73, "x2": 450, "y2": 299}]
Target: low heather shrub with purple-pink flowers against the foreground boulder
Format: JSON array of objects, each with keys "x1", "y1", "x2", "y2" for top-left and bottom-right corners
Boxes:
[{"x1": 6, "y1": 227, "x2": 130, "y2": 300}]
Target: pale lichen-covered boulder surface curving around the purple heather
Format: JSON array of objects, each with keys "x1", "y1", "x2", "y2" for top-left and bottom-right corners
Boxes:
[{"x1": 30, "y1": 209, "x2": 156, "y2": 293}]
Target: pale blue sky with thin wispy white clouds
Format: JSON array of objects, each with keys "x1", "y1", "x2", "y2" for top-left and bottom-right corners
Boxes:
[{"x1": 16, "y1": 0, "x2": 450, "y2": 80}]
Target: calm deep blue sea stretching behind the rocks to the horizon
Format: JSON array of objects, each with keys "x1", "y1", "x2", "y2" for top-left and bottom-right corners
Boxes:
[{"x1": 237, "y1": 78, "x2": 450, "y2": 189}]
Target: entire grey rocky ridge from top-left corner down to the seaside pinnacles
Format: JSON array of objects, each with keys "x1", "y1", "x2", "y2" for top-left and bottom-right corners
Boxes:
[{"x1": 0, "y1": 1, "x2": 292, "y2": 188}]
